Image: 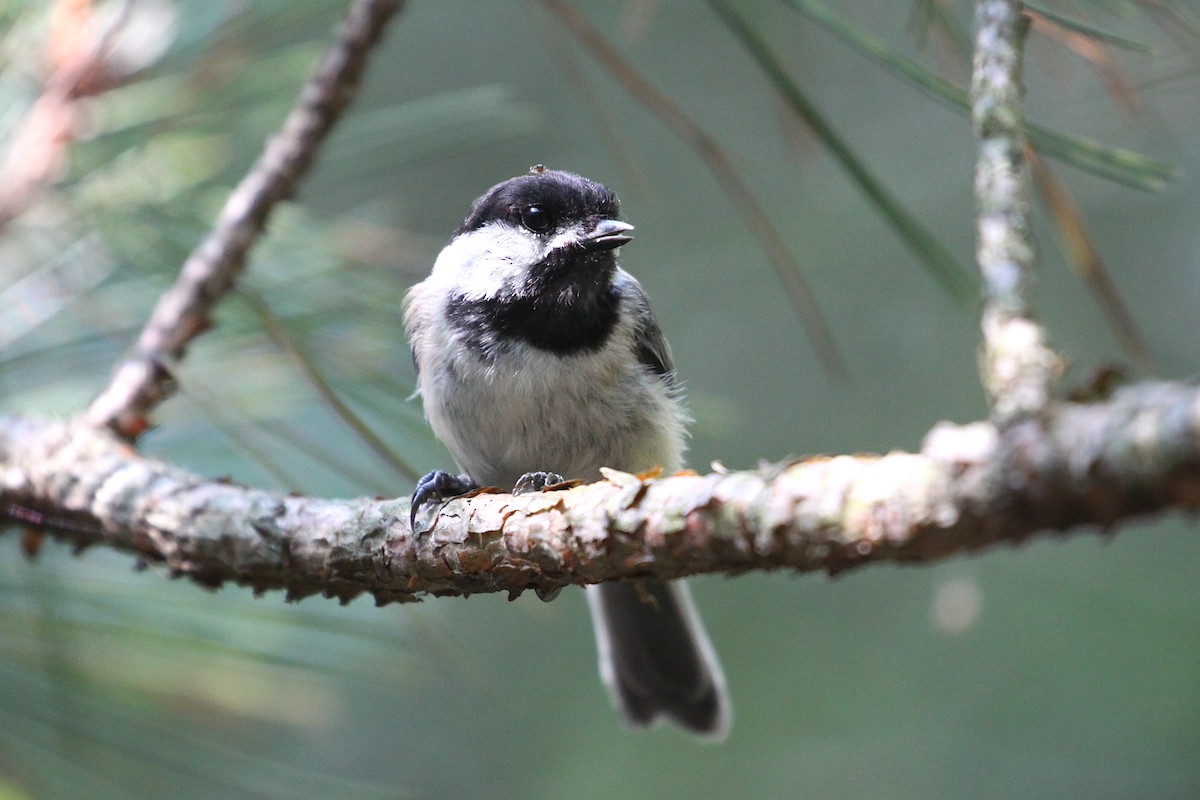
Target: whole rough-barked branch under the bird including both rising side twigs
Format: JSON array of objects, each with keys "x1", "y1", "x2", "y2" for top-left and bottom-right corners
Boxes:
[{"x1": 0, "y1": 0, "x2": 1185, "y2": 603}]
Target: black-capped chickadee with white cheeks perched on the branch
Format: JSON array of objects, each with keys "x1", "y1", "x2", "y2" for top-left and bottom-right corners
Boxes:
[{"x1": 404, "y1": 167, "x2": 730, "y2": 738}]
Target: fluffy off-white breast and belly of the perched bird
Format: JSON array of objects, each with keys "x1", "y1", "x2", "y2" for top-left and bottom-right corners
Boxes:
[{"x1": 407, "y1": 275, "x2": 686, "y2": 488}]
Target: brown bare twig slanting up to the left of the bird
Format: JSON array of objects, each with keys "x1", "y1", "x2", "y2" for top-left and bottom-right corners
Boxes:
[{"x1": 85, "y1": 0, "x2": 402, "y2": 438}]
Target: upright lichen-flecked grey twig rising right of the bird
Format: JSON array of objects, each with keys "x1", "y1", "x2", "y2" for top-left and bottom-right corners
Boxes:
[{"x1": 971, "y1": 0, "x2": 1060, "y2": 425}]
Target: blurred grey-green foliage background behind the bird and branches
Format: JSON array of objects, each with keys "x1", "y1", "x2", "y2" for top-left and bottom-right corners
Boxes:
[{"x1": 0, "y1": 0, "x2": 1200, "y2": 800}]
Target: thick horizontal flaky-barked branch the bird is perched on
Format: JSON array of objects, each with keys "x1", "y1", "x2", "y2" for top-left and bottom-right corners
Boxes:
[{"x1": 0, "y1": 384, "x2": 1200, "y2": 603}]
